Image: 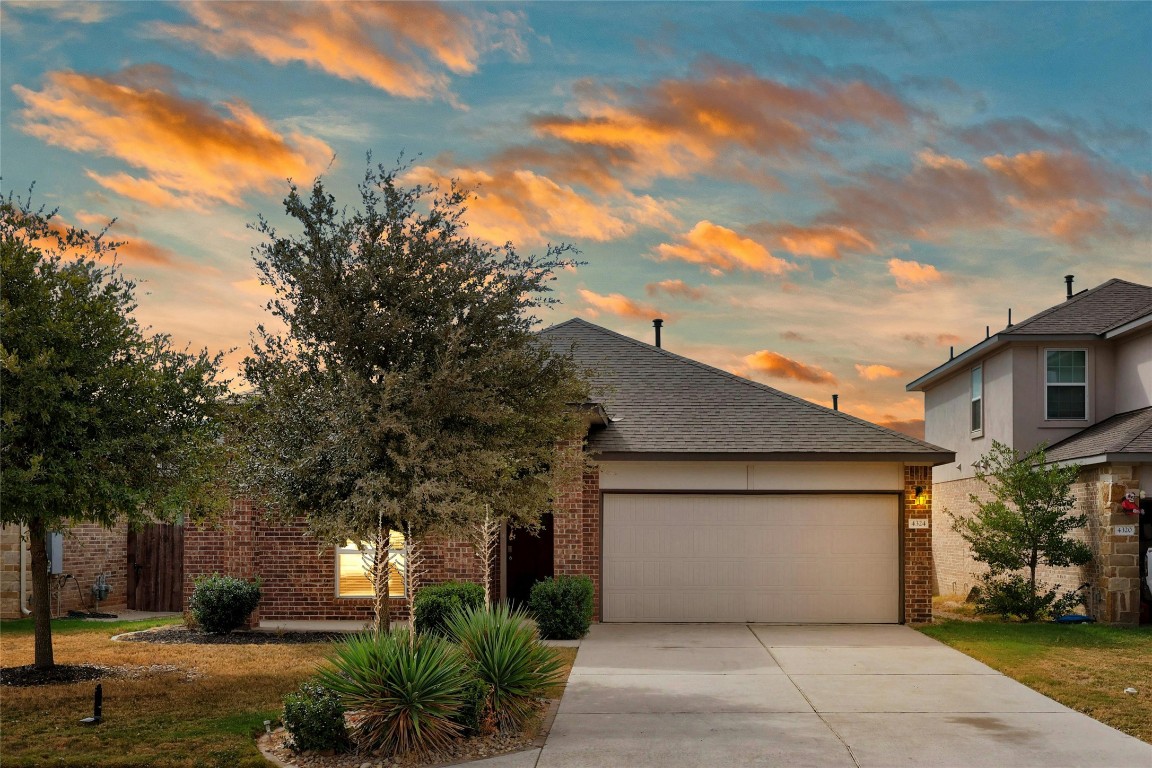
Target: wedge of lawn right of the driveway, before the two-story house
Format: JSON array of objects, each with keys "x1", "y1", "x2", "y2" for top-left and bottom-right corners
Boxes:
[{"x1": 918, "y1": 619, "x2": 1152, "y2": 744}]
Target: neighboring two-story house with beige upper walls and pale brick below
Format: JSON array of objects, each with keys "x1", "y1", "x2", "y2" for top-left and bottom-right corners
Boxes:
[{"x1": 908, "y1": 275, "x2": 1152, "y2": 624}]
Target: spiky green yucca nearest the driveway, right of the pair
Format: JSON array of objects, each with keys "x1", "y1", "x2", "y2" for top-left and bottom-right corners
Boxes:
[{"x1": 448, "y1": 606, "x2": 563, "y2": 731}]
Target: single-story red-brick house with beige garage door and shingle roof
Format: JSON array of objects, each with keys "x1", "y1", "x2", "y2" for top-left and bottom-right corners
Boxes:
[{"x1": 183, "y1": 319, "x2": 954, "y2": 623}]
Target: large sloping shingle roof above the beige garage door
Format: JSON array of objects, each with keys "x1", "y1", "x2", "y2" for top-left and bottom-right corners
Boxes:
[{"x1": 541, "y1": 319, "x2": 954, "y2": 463}]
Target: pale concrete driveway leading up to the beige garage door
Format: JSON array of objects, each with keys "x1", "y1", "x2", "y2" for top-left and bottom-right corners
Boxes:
[{"x1": 532, "y1": 624, "x2": 1152, "y2": 768}]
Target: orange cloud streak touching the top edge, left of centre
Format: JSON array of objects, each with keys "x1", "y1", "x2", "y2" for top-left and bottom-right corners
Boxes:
[{"x1": 157, "y1": 2, "x2": 523, "y2": 100}]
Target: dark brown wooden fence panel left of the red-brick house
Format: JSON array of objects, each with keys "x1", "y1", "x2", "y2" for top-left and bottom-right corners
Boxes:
[{"x1": 128, "y1": 523, "x2": 184, "y2": 611}]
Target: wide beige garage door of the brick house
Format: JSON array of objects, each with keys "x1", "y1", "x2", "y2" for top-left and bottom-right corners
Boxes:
[{"x1": 602, "y1": 493, "x2": 900, "y2": 623}]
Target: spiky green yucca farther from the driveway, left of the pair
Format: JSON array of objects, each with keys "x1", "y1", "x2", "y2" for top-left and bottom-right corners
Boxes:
[{"x1": 318, "y1": 630, "x2": 468, "y2": 754}]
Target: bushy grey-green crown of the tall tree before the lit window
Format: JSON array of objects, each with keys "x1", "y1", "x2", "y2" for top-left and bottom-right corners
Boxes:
[{"x1": 244, "y1": 165, "x2": 586, "y2": 626}]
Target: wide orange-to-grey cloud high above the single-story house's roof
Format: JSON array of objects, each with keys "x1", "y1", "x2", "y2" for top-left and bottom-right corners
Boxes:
[{"x1": 532, "y1": 63, "x2": 912, "y2": 182}]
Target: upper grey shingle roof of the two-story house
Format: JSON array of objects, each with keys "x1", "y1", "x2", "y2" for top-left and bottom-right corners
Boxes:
[{"x1": 1005, "y1": 277, "x2": 1152, "y2": 335}]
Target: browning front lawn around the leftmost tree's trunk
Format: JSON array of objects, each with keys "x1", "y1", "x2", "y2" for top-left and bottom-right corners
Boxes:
[{"x1": 0, "y1": 621, "x2": 331, "y2": 768}]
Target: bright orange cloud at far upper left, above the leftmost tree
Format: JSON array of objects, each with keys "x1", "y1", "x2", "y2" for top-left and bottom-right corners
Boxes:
[{"x1": 13, "y1": 69, "x2": 332, "y2": 208}]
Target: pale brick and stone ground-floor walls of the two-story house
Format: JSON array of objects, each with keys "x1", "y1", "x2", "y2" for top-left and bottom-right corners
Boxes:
[{"x1": 932, "y1": 465, "x2": 1140, "y2": 624}]
